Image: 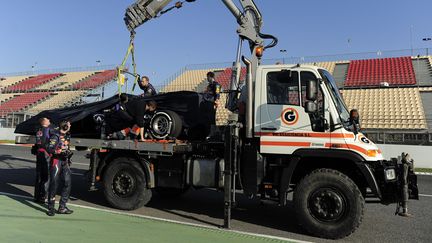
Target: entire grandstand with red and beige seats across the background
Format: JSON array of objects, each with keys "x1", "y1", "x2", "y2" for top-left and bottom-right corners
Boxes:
[{"x1": 0, "y1": 52, "x2": 432, "y2": 143}]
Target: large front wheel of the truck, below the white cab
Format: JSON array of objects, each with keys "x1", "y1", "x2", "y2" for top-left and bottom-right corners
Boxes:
[{"x1": 293, "y1": 169, "x2": 365, "y2": 239}]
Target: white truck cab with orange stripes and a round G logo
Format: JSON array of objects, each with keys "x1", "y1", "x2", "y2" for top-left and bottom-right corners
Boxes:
[{"x1": 254, "y1": 64, "x2": 383, "y2": 161}]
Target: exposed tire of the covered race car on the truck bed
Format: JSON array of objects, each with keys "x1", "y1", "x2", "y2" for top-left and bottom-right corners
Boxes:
[{"x1": 149, "y1": 111, "x2": 183, "y2": 139}]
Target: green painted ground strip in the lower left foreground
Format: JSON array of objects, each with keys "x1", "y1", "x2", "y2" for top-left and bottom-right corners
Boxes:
[{"x1": 0, "y1": 195, "x2": 294, "y2": 243}]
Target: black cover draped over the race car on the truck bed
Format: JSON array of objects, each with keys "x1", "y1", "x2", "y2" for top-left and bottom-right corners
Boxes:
[{"x1": 15, "y1": 91, "x2": 211, "y2": 138}]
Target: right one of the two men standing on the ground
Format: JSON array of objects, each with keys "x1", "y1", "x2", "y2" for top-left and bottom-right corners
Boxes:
[{"x1": 47, "y1": 121, "x2": 73, "y2": 216}]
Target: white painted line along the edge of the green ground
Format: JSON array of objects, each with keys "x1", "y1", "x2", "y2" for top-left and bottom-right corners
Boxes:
[{"x1": 0, "y1": 192, "x2": 310, "y2": 243}]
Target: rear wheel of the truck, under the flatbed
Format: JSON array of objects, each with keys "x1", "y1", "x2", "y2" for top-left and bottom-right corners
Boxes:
[{"x1": 103, "y1": 157, "x2": 152, "y2": 210}]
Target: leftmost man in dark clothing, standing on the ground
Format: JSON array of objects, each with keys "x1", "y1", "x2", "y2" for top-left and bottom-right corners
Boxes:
[{"x1": 32, "y1": 117, "x2": 54, "y2": 203}]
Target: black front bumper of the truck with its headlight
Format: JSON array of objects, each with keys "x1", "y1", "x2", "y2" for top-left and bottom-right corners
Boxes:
[{"x1": 369, "y1": 157, "x2": 419, "y2": 204}]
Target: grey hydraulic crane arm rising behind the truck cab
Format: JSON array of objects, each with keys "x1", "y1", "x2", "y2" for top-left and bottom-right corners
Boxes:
[{"x1": 124, "y1": 0, "x2": 277, "y2": 138}]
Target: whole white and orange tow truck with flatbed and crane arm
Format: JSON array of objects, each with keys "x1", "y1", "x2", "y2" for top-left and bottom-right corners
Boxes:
[{"x1": 17, "y1": 0, "x2": 418, "y2": 239}]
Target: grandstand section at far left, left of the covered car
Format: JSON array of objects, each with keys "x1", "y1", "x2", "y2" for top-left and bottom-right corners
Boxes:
[{"x1": 0, "y1": 69, "x2": 117, "y2": 126}]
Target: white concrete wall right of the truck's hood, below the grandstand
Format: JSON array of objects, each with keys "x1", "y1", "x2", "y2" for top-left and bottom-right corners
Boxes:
[{"x1": 378, "y1": 144, "x2": 432, "y2": 168}]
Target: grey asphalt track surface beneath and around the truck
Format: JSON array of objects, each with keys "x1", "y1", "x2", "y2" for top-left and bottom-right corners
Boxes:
[{"x1": 0, "y1": 145, "x2": 432, "y2": 242}]
